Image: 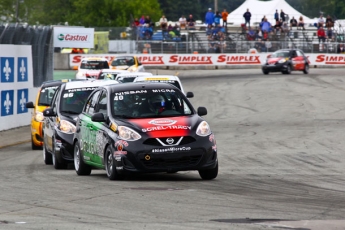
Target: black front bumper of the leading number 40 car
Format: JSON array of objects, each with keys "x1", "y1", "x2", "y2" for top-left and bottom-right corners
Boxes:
[{"x1": 113, "y1": 137, "x2": 217, "y2": 173}]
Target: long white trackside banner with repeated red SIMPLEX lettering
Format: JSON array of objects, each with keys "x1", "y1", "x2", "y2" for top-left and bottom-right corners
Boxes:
[{"x1": 70, "y1": 53, "x2": 345, "y2": 68}]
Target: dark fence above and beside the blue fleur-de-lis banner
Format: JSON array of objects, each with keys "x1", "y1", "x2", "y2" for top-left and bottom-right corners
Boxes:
[{"x1": 0, "y1": 23, "x2": 53, "y2": 87}]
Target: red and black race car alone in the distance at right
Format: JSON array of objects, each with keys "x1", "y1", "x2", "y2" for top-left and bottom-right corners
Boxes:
[{"x1": 262, "y1": 49, "x2": 309, "y2": 74}]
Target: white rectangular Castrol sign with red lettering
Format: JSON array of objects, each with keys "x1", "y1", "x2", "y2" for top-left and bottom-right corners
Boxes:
[{"x1": 53, "y1": 26, "x2": 94, "y2": 48}]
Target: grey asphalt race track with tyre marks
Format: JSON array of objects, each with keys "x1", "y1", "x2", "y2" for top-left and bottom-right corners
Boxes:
[{"x1": 0, "y1": 69, "x2": 345, "y2": 230}]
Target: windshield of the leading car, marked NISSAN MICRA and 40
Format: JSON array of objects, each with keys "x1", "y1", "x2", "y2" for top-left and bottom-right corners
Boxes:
[{"x1": 110, "y1": 89, "x2": 193, "y2": 118}]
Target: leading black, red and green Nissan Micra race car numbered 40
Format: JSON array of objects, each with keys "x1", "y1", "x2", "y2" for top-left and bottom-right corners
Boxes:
[{"x1": 73, "y1": 82, "x2": 218, "y2": 180}]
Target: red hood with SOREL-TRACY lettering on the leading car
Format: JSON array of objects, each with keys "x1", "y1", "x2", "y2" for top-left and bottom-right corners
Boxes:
[{"x1": 121, "y1": 115, "x2": 202, "y2": 138}]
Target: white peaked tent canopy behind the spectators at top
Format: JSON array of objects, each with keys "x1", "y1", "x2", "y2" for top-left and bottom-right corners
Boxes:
[{"x1": 227, "y1": 0, "x2": 315, "y2": 25}]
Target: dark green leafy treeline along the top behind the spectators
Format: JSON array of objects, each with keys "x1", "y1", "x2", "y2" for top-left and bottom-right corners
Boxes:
[{"x1": 0, "y1": 0, "x2": 345, "y2": 27}]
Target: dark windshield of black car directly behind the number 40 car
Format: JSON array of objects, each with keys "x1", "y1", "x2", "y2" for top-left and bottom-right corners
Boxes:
[{"x1": 60, "y1": 88, "x2": 95, "y2": 114}]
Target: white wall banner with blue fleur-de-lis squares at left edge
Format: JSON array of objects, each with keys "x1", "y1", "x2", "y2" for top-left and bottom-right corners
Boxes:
[{"x1": 0, "y1": 45, "x2": 37, "y2": 131}]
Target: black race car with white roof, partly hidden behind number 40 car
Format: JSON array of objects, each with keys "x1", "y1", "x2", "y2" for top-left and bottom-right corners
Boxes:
[{"x1": 43, "y1": 80, "x2": 118, "y2": 169}]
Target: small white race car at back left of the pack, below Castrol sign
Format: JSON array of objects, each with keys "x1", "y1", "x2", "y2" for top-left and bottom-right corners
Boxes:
[{"x1": 75, "y1": 57, "x2": 109, "y2": 79}]
